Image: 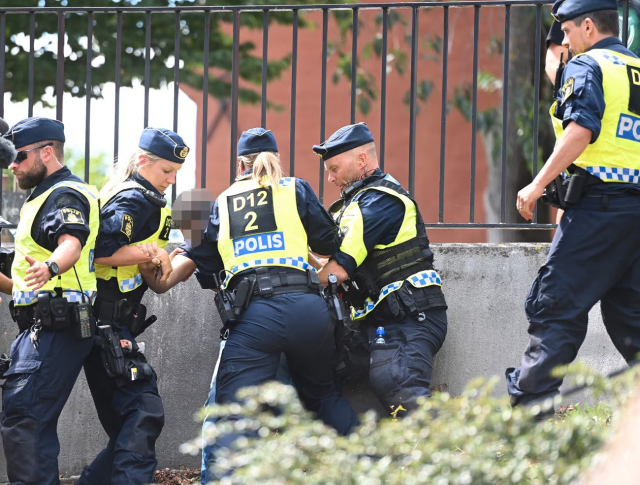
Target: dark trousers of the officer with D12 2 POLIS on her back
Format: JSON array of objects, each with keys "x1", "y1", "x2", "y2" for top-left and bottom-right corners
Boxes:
[{"x1": 202, "y1": 293, "x2": 357, "y2": 483}]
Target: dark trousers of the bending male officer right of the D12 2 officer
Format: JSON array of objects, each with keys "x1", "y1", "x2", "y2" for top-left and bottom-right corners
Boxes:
[{"x1": 365, "y1": 308, "x2": 447, "y2": 413}]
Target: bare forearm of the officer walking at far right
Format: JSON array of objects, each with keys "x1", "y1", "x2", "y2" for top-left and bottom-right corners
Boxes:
[{"x1": 533, "y1": 121, "x2": 593, "y2": 187}]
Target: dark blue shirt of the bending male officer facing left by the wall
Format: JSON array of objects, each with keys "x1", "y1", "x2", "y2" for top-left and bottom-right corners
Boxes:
[{"x1": 333, "y1": 169, "x2": 405, "y2": 276}]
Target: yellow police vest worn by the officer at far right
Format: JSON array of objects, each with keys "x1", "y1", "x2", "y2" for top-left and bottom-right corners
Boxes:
[{"x1": 550, "y1": 49, "x2": 640, "y2": 184}]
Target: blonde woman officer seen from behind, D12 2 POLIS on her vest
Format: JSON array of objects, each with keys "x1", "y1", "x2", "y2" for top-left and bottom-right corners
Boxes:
[{"x1": 148, "y1": 128, "x2": 356, "y2": 483}]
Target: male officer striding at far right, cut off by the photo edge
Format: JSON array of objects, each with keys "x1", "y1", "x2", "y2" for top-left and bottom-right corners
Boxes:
[{"x1": 506, "y1": 0, "x2": 640, "y2": 414}]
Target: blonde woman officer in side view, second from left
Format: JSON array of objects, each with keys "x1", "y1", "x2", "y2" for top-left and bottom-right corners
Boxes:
[{"x1": 78, "y1": 128, "x2": 189, "y2": 485}]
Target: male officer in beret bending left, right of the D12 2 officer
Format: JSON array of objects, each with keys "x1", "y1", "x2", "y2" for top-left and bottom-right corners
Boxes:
[{"x1": 313, "y1": 123, "x2": 447, "y2": 412}]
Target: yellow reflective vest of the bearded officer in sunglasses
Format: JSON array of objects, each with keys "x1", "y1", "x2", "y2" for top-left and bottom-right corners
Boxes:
[{"x1": 11, "y1": 181, "x2": 100, "y2": 306}]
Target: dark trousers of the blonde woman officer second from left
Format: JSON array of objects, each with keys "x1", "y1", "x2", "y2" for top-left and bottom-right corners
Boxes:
[{"x1": 77, "y1": 322, "x2": 164, "y2": 485}]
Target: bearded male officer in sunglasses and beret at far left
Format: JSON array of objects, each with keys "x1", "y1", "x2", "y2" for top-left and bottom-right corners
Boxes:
[{"x1": 0, "y1": 118, "x2": 99, "y2": 485}]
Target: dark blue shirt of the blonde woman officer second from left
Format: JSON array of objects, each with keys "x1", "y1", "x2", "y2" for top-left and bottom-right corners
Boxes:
[{"x1": 96, "y1": 174, "x2": 162, "y2": 258}]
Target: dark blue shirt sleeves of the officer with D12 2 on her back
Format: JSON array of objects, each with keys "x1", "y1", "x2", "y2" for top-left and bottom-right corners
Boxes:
[{"x1": 180, "y1": 171, "x2": 340, "y2": 289}]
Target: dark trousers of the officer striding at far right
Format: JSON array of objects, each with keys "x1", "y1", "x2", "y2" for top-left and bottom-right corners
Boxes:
[{"x1": 506, "y1": 189, "x2": 640, "y2": 405}]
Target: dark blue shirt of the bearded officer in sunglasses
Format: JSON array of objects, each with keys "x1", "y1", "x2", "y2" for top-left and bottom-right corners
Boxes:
[{"x1": 27, "y1": 167, "x2": 90, "y2": 252}]
